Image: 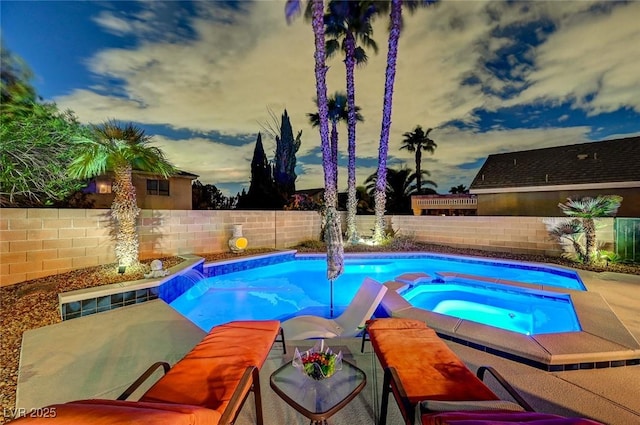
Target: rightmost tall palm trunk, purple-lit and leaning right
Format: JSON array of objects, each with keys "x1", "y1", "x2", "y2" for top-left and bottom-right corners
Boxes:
[{"x1": 373, "y1": 0, "x2": 402, "y2": 242}]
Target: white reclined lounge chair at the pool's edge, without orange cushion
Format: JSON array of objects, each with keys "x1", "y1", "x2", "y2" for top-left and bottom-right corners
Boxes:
[{"x1": 282, "y1": 278, "x2": 387, "y2": 340}]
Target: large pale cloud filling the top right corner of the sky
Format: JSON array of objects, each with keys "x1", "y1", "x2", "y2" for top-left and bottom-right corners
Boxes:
[{"x1": 507, "y1": 2, "x2": 640, "y2": 115}]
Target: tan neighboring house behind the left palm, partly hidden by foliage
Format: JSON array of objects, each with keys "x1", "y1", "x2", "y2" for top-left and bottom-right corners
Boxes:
[{"x1": 84, "y1": 170, "x2": 198, "y2": 210}]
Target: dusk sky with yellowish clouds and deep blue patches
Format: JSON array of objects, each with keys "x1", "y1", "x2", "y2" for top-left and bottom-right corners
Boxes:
[{"x1": 0, "y1": 0, "x2": 640, "y2": 194}]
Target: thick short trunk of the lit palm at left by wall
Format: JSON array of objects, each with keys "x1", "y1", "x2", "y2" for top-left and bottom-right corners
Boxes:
[{"x1": 111, "y1": 163, "x2": 140, "y2": 266}]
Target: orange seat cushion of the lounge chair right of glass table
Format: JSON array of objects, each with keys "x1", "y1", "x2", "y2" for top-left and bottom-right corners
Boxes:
[{"x1": 368, "y1": 319, "x2": 499, "y2": 404}]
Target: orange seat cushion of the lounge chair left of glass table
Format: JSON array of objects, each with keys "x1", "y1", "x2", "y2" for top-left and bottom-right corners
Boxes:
[{"x1": 140, "y1": 320, "x2": 280, "y2": 412}]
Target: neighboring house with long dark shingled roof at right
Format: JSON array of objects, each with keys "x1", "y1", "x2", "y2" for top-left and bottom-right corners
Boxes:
[{"x1": 469, "y1": 136, "x2": 640, "y2": 217}]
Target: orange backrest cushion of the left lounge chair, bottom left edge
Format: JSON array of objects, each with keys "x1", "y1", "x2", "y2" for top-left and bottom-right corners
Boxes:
[{"x1": 6, "y1": 400, "x2": 221, "y2": 425}]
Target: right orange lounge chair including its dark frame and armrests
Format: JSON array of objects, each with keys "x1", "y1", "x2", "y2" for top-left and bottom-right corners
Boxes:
[{"x1": 366, "y1": 318, "x2": 598, "y2": 425}]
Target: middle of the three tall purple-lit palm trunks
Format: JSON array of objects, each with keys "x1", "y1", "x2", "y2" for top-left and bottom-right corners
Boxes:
[{"x1": 345, "y1": 33, "x2": 358, "y2": 243}]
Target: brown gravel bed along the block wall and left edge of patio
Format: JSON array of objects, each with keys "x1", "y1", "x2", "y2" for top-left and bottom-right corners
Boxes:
[{"x1": 0, "y1": 239, "x2": 640, "y2": 423}]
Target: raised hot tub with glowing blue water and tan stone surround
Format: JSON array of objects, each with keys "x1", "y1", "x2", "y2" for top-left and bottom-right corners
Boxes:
[{"x1": 381, "y1": 272, "x2": 640, "y2": 371}]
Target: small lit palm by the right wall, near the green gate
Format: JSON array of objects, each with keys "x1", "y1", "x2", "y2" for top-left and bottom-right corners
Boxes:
[{"x1": 558, "y1": 195, "x2": 622, "y2": 264}]
